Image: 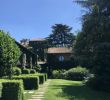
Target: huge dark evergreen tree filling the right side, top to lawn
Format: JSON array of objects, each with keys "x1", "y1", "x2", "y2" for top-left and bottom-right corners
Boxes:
[{"x1": 74, "y1": 0, "x2": 110, "y2": 90}]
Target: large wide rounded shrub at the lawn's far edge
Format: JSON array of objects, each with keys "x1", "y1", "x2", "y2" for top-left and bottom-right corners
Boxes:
[{"x1": 64, "y1": 66, "x2": 89, "y2": 81}]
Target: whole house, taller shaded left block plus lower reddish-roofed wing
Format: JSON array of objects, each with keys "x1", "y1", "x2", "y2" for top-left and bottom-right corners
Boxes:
[{"x1": 18, "y1": 38, "x2": 72, "y2": 64}]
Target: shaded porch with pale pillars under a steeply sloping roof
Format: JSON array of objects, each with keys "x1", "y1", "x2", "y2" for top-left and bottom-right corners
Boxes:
[{"x1": 16, "y1": 41, "x2": 37, "y2": 68}]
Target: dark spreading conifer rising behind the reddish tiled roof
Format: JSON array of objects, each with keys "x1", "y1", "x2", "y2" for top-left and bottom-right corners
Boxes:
[{"x1": 48, "y1": 24, "x2": 75, "y2": 47}]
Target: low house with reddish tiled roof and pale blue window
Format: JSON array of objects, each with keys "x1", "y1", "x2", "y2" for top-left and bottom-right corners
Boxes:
[{"x1": 47, "y1": 47, "x2": 72, "y2": 63}]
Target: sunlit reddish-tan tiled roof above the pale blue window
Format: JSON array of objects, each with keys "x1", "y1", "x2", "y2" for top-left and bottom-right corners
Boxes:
[{"x1": 48, "y1": 47, "x2": 72, "y2": 54}]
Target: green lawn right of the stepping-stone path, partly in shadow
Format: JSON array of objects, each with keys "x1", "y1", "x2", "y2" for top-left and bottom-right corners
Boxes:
[{"x1": 43, "y1": 79, "x2": 110, "y2": 100}]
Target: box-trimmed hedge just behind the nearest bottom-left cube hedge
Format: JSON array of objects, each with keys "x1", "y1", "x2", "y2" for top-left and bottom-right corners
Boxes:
[{"x1": 13, "y1": 74, "x2": 39, "y2": 90}]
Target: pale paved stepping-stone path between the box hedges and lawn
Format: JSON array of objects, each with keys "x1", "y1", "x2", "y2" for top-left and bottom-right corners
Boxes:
[{"x1": 28, "y1": 80, "x2": 51, "y2": 100}]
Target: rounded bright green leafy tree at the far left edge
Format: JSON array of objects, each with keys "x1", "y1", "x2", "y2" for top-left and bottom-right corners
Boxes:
[{"x1": 0, "y1": 30, "x2": 20, "y2": 76}]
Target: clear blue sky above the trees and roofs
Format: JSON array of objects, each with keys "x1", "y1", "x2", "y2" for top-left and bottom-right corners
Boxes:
[{"x1": 0, "y1": 0, "x2": 82, "y2": 41}]
